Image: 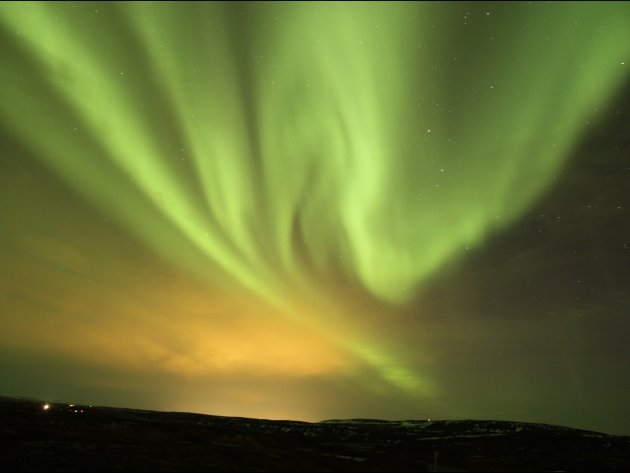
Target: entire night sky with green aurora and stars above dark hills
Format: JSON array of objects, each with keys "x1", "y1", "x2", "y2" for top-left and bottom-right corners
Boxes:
[{"x1": 0, "y1": 2, "x2": 630, "y2": 435}]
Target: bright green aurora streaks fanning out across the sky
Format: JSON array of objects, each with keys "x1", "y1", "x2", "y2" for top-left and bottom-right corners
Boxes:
[{"x1": 0, "y1": 2, "x2": 630, "y2": 434}]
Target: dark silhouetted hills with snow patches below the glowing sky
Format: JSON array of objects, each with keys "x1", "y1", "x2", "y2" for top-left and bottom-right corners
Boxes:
[{"x1": 0, "y1": 397, "x2": 630, "y2": 472}]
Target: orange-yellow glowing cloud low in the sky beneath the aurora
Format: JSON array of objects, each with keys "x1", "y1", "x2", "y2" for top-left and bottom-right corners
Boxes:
[{"x1": 0, "y1": 258, "x2": 352, "y2": 378}]
